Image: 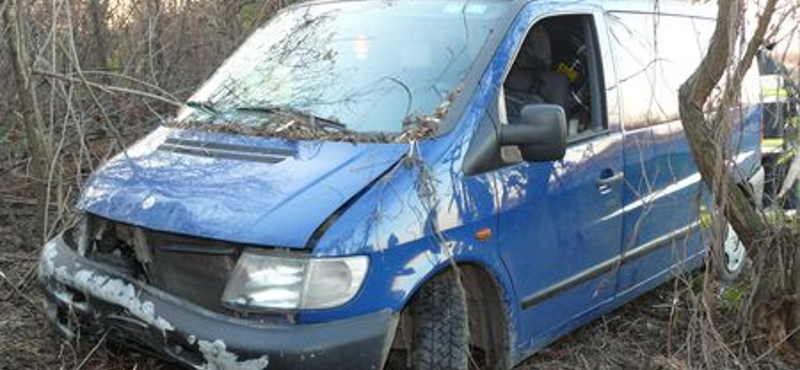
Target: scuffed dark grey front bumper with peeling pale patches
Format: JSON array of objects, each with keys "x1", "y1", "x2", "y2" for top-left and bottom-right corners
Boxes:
[{"x1": 39, "y1": 235, "x2": 398, "y2": 370}]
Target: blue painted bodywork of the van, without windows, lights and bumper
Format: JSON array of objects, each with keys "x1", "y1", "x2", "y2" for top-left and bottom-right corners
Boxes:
[{"x1": 73, "y1": 2, "x2": 761, "y2": 361}]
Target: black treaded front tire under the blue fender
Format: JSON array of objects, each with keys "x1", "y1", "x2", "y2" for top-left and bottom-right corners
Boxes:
[{"x1": 411, "y1": 273, "x2": 469, "y2": 370}]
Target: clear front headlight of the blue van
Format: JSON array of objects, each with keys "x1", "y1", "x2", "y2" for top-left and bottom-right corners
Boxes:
[{"x1": 222, "y1": 250, "x2": 369, "y2": 310}]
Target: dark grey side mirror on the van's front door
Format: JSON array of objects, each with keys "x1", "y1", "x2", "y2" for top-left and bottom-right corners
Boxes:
[{"x1": 500, "y1": 104, "x2": 567, "y2": 162}]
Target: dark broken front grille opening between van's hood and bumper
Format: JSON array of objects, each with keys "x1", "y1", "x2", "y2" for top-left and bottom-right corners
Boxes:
[{"x1": 87, "y1": 217, "x2": 242, "y2": 314}]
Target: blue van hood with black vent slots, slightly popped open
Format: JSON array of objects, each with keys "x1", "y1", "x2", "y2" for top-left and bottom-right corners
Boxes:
[{"x1": 78, "y1": 127, "x2": 407, "y2": 248}]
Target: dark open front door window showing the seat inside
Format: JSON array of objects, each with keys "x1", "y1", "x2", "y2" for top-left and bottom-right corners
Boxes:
[{"x1": 500, "y1": 15, "x2": 606, "y2": 138}]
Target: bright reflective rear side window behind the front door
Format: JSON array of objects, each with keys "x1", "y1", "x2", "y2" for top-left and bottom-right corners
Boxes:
[{"x1": 608, "y1": 12, "x2": 714, "y2": 129}]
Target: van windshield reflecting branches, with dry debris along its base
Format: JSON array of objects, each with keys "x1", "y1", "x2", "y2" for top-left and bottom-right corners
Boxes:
[{"x1": 179, "y1": 0, "x2": 506, "y2": 133}]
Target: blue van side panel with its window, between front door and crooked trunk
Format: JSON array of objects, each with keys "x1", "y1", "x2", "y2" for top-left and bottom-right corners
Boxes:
[{"x1": 607, "y1": 12, "x2": 713, "y2": 293}]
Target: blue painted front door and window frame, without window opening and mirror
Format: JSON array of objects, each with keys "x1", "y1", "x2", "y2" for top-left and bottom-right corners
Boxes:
[{"x1": 496, "y1": 2, "x2": 623, "y2": 354}]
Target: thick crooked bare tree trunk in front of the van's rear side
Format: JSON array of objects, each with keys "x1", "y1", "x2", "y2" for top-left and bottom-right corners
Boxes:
[{"x1": 679, "y1": 0, "x2": 800, "y2": 348}]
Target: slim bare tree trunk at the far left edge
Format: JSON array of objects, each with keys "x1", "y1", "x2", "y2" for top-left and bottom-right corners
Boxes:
[{"x1": 3, "y1": 0, "x2": 52, "y2": 246}]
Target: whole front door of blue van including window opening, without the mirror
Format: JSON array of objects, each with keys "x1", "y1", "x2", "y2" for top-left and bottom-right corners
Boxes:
[{"x1": 496, "y1": 11, "x2": 624, "y2": 347}]
